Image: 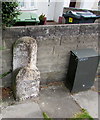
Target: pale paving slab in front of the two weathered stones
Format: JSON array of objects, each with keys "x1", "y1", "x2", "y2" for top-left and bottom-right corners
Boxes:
[{"x1": 2, "y1": 102, "x2": 43, "y2": 118}]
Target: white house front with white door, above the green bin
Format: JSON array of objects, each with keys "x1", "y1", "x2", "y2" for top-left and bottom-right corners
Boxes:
[{"x1": 19, "y1": 0, "x2": 64, "y2": 22}]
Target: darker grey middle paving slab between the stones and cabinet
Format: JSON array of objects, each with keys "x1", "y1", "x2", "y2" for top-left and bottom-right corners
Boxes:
[{"x1": 39, "y1": 86, "x2": 81, "y2": 118}]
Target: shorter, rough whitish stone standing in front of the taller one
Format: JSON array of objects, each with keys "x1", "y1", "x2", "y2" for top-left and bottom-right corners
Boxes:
[{"x1": 16, "y1": 66, "x2": 40, "y2": 100}]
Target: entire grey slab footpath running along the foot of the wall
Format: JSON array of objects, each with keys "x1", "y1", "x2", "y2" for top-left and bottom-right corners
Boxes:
[{"x1": 2, "y1": 85, "x2": 98, "y2": 118}]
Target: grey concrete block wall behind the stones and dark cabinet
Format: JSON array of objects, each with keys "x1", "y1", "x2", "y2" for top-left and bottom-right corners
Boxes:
[{"x1": 0, "y1": 24, "x2": 99, "y2": 86}]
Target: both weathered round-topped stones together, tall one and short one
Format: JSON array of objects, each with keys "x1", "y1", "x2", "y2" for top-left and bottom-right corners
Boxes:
[{"x1": 13, "y1": 37, "x2": 40, "y2": 100}]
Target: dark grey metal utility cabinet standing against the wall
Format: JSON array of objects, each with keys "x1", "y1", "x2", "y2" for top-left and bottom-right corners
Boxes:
[{"x1": 66, "y1": 49, "x2": 99, "y2": 93}]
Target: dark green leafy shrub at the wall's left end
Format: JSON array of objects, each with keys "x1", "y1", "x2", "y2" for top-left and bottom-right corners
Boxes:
[{"x1": 2, "y1": 2, "x2": 20, "y2": 27}]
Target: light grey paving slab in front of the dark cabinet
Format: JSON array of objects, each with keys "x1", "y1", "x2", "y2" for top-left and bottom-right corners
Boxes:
[{"x1": 72, "y1": 90, "x2": 98, "y2": 118}]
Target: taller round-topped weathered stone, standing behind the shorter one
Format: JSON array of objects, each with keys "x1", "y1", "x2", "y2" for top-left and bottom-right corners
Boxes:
[{"x1": 13, "y1": 37, "x2": 37, "y2": 70}]
